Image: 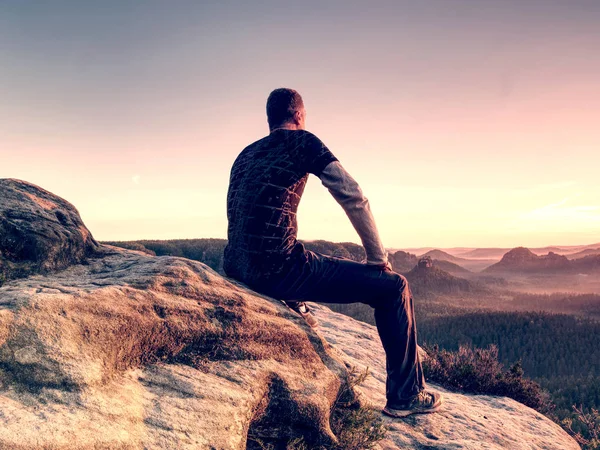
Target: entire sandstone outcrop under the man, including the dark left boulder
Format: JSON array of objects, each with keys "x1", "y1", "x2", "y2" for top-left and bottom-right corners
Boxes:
[{"x1": 0, "y1": 180, "x2": 578, "y2": 449}]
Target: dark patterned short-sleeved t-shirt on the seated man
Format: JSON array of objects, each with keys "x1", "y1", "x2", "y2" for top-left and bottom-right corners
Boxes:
[{"x1": 223, "y1": 129, "x2": 338, "y2": 284}]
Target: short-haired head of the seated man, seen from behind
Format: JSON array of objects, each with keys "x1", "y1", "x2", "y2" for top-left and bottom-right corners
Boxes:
[{"x1": 267, "y1": 88, "x2": 306, "y2": 131}]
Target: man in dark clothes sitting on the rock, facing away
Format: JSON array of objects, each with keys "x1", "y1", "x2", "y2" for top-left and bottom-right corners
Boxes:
[{"x1": 224, "y1": 88, "x2": 442, "y2": 417}]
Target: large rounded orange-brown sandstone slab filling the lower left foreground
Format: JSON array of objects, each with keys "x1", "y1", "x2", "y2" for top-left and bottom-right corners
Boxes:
[{"x1": 0, "y1": 248, "x2": 352, "y2": 449}]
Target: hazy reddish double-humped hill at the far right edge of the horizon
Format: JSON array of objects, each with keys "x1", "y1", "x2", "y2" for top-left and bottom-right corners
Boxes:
[{"x1": 483, "y1": 247, "x2": 600, "y2": 275}]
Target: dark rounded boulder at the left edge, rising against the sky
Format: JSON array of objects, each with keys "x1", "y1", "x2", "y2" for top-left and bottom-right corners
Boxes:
[{"x1": 0, "y1": 178, "x2": 98, "y2": 286}]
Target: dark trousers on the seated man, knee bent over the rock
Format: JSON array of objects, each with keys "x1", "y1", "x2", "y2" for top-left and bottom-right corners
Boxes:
[{"x1": 251, "y1": 251, "x2": 425, "y2": 406}]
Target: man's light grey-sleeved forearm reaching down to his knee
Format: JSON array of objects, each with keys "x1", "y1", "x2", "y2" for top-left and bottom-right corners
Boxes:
[{"x1": 319, "y1": 161, "x2": 388, "y2": 266}]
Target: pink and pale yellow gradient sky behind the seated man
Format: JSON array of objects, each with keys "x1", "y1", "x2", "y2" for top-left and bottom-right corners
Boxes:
[{"x1": 0, "y1": 0, "x2": 600, "y2": 248}]
